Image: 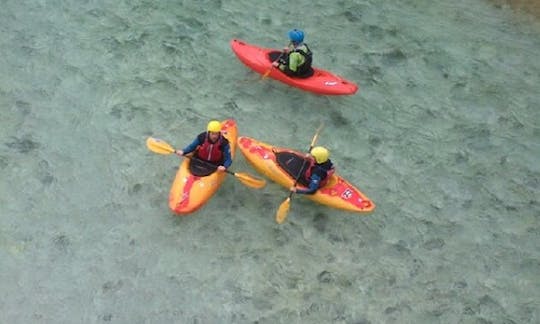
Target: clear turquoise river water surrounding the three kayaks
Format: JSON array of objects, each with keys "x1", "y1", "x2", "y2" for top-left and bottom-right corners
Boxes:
[{"x1": 0, "y1": 0, "x2": 540, "y2": 323}]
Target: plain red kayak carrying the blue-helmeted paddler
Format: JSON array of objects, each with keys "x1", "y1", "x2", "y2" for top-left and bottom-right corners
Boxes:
[{"x1": 231, "y1": 39, "x2": 358, "y2": 95}]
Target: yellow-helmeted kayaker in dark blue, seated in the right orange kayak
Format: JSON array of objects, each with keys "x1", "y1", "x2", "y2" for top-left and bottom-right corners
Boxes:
[{"x1": 290, "y1": 146, "x2": 334, "y2": 195}]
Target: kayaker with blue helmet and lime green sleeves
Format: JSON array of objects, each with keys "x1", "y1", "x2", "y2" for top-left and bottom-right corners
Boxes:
[{"x1": 272, "y1": 29, "x2": 313, "y2": 78}]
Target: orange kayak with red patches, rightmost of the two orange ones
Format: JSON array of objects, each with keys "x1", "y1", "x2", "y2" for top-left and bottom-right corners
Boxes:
[{"x1": 238, "y1": 136, "x2": 375, "y2": 213}]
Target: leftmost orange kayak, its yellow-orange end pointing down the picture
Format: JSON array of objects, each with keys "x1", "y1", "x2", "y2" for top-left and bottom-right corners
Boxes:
[{"x1": 169, "y1": 119, "x2": 238, "y2": 214}]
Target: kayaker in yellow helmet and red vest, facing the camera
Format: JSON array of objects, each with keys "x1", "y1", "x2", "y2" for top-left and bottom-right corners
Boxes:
[{"x1": 175, "y1": 120, "x2": 232, "y2": 171}]
